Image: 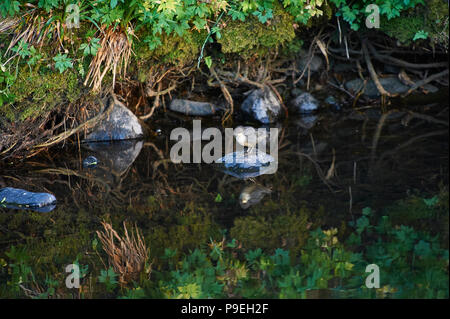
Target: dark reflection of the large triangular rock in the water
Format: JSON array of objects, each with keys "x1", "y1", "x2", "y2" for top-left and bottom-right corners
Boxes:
[{"x1": 84, "y1": 140, "x2": 143, "y2": 175}]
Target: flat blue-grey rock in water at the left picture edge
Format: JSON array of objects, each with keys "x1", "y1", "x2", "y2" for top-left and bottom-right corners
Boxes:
[{"x1": 0, "y1": 187, "x2": 56, "y2": 213}]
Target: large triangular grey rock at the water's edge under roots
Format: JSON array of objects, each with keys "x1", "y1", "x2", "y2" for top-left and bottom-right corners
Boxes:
[{"x1": 84, "y1": 95, "x2": 144, "y2": 142}]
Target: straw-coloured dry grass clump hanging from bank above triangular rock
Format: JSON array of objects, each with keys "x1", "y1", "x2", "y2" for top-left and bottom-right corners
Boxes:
[{"x1": 84, "y1": 28, "x2": 132, "y2": 91}]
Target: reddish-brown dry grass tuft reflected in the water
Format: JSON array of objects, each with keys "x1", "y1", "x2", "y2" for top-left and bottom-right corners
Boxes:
[{"x1": 97, "y1": 221, "x2": 149, "y2": 284}]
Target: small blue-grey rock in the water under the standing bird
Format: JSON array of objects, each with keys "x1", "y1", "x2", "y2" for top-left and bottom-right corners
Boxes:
[{"x1": 215, "y1": 150, "x2": 278, "y2": 179}]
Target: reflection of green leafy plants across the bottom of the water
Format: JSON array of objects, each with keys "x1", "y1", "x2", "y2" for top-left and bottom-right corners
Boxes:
[{"x1": 0, "y1": 190, "x2": 449, "y2": 298}]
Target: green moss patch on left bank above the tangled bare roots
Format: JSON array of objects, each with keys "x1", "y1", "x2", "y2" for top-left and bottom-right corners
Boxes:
[{"x1": 0, "y1": 66, "x2": 81, "y2": 121}]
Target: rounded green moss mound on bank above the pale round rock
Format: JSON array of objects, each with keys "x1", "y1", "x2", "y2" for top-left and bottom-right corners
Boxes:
[{"x1": 218, "y1": 5, "x2": 295, "y2": 58}]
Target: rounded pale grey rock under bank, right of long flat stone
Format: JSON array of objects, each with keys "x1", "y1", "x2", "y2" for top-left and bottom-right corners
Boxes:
[{"x1": 241, "y1": 87, "x2": 281, "y2": 124}]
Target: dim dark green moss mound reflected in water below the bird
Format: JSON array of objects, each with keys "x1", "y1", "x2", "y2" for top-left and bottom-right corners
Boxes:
[{"x1": 230, "y1": 208, "x2": 310, "y2": 255}]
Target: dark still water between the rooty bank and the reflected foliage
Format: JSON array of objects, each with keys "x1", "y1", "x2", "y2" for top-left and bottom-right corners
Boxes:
[{"x1": 0, "y1": 96, "x2": 448, "y2": 298}]
